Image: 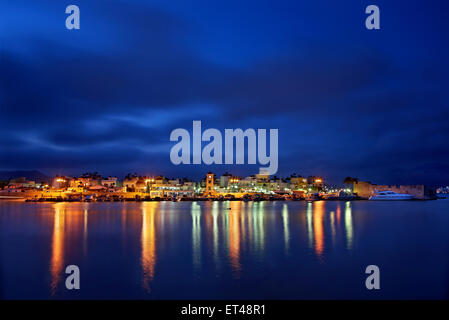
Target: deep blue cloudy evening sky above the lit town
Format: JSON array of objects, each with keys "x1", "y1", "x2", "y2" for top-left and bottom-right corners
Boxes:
[{"x1": 0, "y1": 0, "x2": 449, "y2": 185}]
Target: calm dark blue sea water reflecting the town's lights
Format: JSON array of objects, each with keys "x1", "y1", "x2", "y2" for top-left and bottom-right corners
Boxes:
[{"x1": 0, "y1": 200, "x2": 449, "y2": 299}]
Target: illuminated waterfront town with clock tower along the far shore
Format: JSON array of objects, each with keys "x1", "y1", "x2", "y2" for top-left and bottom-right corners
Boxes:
[{"x1": 0, "y1": 172, "x2": 443, "y2": 202}]
